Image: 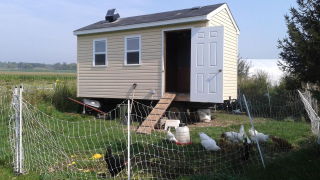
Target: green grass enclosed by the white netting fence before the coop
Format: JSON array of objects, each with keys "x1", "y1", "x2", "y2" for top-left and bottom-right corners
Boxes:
[{"x1": 0, "y1": 104, "x2": 311, "y2": 178}]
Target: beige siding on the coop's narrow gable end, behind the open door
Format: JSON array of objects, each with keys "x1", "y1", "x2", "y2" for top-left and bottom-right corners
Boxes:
[{"x1": 209, "y1": 9, "x2": 238, "y2": 100}]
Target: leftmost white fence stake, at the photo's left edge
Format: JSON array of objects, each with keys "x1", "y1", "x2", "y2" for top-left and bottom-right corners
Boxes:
[{"x1": 13, "y1": 86, "x2": 20, "y2": 172}]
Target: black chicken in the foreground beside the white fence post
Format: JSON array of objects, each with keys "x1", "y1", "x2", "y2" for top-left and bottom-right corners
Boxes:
[{"x1": 104, "y1": 148, "x2": 127, "y2": 177}]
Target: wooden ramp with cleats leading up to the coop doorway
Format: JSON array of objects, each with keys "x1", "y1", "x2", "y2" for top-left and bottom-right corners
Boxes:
[{"x1": 136, "y1": 93, "x2": 176, "y2": 134}]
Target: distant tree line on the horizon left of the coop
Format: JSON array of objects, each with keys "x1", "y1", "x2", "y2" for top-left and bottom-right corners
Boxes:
[{"x1": 0, "y1": 62, "x2": 77, "y2": 70}]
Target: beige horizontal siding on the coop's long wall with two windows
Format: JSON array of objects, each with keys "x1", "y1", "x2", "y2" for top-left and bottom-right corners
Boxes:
[{"x1": 77, "y1": 22, "x2": 206, "y2": 99}]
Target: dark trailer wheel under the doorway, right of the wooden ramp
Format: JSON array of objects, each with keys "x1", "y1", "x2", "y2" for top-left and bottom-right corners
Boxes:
[{"x1": 166, "y1": 102, "x2": 188, "y2": 123}]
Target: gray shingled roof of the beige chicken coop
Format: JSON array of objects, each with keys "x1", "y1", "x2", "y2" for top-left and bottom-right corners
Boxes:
[{"x1": 74, "y1": 3, "x2": 224, "y2": 32}]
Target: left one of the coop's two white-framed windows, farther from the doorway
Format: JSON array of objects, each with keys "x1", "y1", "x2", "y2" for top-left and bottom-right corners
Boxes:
[{"x1": 93, "y1": 39, "x2": 108, "y2": 66}]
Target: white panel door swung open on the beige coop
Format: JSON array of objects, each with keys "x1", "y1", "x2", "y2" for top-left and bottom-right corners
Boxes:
[{"x1": 190, "y1": 26, "x2": 224, "y2": 103}]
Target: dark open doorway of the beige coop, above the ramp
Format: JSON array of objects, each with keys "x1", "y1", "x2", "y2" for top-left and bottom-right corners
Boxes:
[{"x1": 164, "y1": 29, "x2": 191, "y2": 94}]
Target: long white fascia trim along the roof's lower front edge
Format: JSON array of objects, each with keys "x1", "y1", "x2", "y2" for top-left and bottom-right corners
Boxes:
[{"x1": 73, "y1": 15, "x2": 208, "y2": 35}]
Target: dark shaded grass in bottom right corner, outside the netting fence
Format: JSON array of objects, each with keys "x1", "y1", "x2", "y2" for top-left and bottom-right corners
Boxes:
[{"x1": 178, "y1": 146, "x2": 320, "y2": 180}]
